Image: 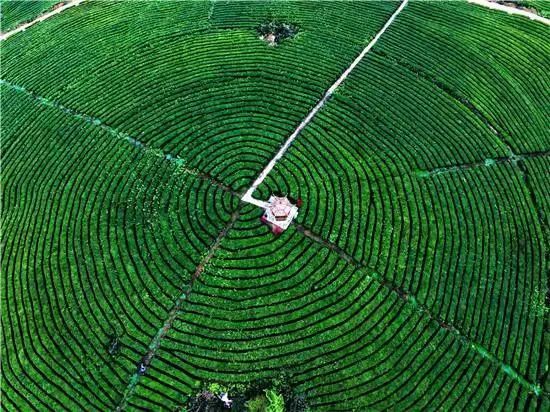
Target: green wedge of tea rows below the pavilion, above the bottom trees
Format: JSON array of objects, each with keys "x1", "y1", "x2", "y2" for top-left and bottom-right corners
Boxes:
[{"x1": 126, "y1": 205, "x2": 544, "y2": 410}]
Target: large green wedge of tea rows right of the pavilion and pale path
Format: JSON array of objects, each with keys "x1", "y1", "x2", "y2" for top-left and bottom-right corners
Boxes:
[{"x1": 252, "y1": 3, "x2": 550, "y2": 402}]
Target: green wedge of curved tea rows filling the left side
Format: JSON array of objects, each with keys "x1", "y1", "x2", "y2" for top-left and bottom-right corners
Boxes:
[{"x1": 2, "y1": 85, "x2": 236, "y2": 410}]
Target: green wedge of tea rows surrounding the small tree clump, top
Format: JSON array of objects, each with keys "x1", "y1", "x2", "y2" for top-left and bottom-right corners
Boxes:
[{"x1": 2, "y1": 2, "x2": 396, "y2": 189}]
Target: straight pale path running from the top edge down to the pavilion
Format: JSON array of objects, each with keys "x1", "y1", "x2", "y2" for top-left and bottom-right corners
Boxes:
[{"x1": 242, "y1": 0, "x2": 409, "y2": 208}]
